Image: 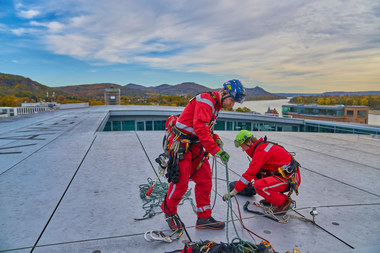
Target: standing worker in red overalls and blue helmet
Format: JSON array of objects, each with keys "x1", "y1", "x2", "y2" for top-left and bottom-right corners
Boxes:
[{"x1": 161, "y1": 79, "x2": 245, "y2": 230}]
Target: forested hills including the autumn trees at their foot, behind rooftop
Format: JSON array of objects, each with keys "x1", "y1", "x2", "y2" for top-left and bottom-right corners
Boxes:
[{"x1": 0, "y1": 73, "x2": 281, "y2": 107}]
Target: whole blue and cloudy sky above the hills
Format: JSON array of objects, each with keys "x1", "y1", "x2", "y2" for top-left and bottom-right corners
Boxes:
[{"x1": 0, "y1": 0, "x2": 380, "y2": 93}]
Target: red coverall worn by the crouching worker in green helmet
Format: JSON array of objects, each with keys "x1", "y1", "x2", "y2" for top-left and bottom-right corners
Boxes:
[{"x1": 235, "y1": 138, "x2": 301, "y2": 206}]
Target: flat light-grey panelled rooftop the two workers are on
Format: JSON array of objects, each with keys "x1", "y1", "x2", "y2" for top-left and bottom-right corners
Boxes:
[{"x1": 0, "y1": 106, "x2": 380, "y2": 253}]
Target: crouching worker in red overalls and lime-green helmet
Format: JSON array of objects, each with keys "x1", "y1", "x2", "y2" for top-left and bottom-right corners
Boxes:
[{"x1": 223, "y1": 130, "x2": 301, "y2": 212}]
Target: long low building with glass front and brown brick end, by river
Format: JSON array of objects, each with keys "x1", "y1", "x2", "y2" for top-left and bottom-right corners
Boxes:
[{"x1": 282, "y1": 104, "x2": 369, "y2": 124}]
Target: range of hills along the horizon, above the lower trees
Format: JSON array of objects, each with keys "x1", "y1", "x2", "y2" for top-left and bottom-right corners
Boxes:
[{"x1": 0, "y1": 73, "x2": 282, "y2": 99}]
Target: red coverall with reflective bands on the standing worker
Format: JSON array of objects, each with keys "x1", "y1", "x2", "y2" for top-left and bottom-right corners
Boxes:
[{"x1": 161, "y1": 91, "x2": 222, "y2": 218}]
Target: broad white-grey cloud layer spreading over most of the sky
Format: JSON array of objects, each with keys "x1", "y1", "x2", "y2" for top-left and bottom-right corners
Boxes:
[{"x1": 7, "y1": 0, "x2": 380, "y2": 91}]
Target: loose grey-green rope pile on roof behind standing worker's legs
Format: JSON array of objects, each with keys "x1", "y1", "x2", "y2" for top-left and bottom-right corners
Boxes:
[{"x1": 135, "y1": 177, "x2": 197, "y2": 220}]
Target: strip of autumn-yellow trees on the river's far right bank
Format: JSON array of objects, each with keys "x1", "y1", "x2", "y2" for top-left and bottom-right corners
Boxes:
[{"x1": 289, "y1": 95, "x2": 380, "y2": 110}]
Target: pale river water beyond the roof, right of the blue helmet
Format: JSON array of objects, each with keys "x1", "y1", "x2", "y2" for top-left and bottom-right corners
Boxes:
[{"x1": 234, "y1": 99, "x2": 380, "y2": 126}]
